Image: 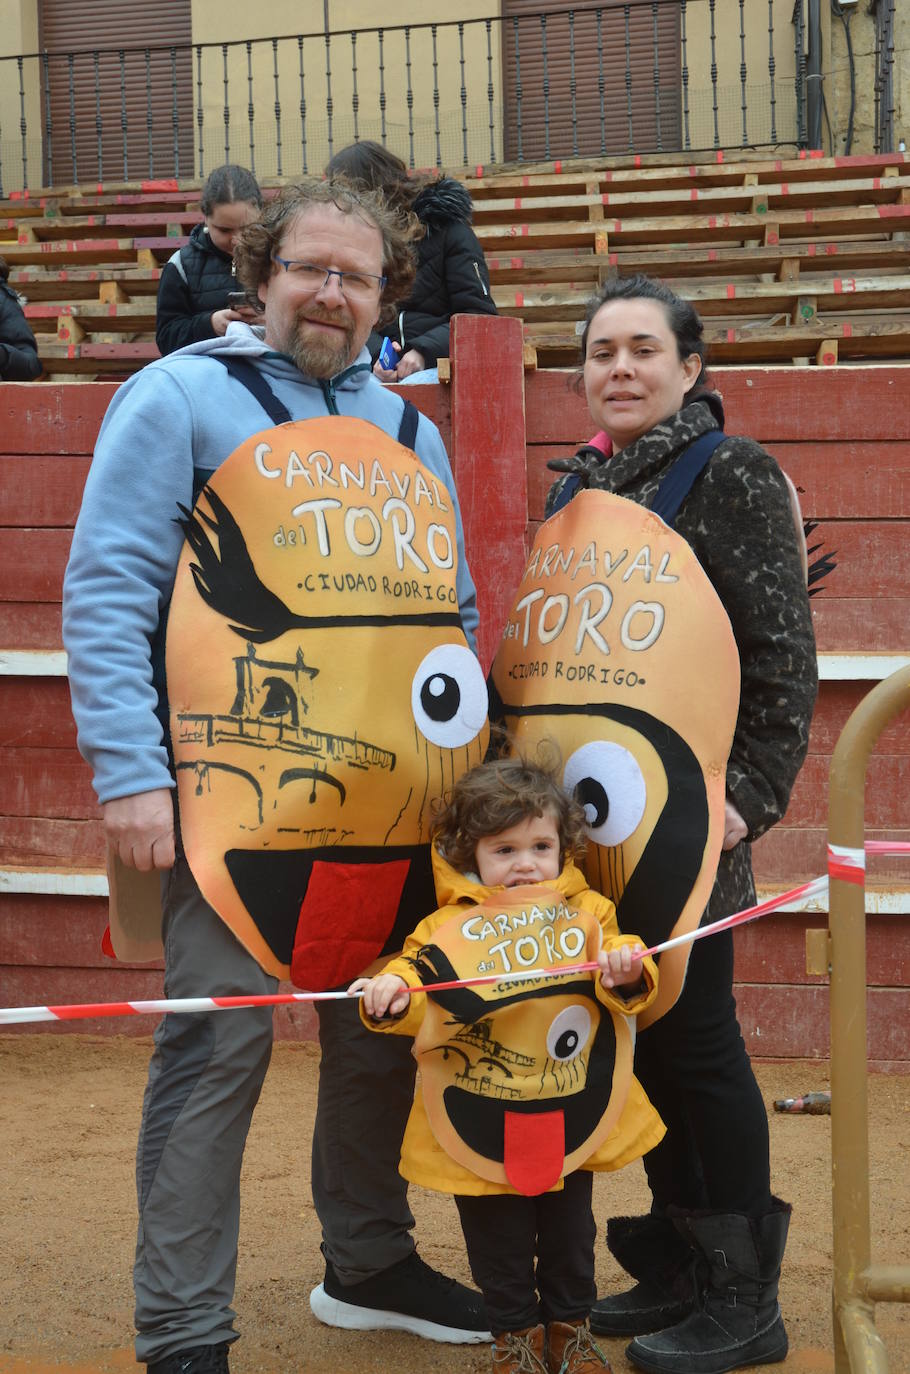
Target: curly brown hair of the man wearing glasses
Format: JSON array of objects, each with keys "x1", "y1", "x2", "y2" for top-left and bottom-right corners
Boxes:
[{"x1": 234, "y1": 180, "x2": 421, "y2": 306}]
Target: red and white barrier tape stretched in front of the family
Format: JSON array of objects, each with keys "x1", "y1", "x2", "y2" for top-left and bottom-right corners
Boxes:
[{"x1": 0, "y1": 840, "x2": 910, "y2": 1026}]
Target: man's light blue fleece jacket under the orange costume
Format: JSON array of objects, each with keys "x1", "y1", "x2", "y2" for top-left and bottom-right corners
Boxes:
[{"x1": 63, "y1": 323, "x2": 478, "y2": 802}]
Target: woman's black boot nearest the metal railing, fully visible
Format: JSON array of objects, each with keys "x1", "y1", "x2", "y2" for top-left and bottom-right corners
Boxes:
[{"x1": 625, "y1": 1198, "x2": 790, "y2": 1374}]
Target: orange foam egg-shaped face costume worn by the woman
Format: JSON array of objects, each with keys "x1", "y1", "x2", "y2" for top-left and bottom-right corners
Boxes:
[{"x1": 491, "y1": 491, "x2": 740, "y2": 1026}]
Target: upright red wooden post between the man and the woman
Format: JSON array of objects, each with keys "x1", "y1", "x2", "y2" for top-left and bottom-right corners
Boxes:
[{"x1": 450, "y1": 315, "x2": 528, "y2": 669}]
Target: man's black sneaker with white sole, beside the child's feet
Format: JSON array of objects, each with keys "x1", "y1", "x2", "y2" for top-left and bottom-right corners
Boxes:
[{"x1": 309, "y1": 1250, "x2": 492, "y2": 1345}]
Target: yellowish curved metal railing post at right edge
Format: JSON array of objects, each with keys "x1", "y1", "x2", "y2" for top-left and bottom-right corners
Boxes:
[{"x1": 828, "y1": 668, "x2": 910, "y2": 1374}]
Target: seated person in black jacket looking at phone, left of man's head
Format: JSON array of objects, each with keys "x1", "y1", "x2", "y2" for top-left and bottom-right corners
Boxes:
[{"x1": 155, "y1": 162, "x2": 263, "y2": 354}]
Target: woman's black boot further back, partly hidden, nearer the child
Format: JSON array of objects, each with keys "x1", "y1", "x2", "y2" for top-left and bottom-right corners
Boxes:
[{"x1": 591, "y1": 1212, "x2": 700, "y2": 1336}]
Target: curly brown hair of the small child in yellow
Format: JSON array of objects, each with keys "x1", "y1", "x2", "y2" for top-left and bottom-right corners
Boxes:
[{"x1": 432, "y1": 757, "x2": 588, "y2": 872}]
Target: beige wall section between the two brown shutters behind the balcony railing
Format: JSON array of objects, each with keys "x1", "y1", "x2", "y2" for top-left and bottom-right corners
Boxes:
[{"x1": 192, "y1": 0, "x2": 502, "y2": 177}]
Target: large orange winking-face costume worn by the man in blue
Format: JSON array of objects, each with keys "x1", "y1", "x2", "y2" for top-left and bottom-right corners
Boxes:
[{"x1": 166, "y1": 416, "x2": 487, "y2": 989}]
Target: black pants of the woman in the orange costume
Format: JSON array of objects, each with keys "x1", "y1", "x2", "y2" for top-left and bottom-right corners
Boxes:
[{"x1": 635, "y1": 930, "x2": 771, "y2": 1216}]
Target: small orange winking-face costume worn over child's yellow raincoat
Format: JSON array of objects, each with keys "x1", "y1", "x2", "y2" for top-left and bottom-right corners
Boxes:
[{"x1": 414, "y1": 883, "x2": 632, "y2": 1194}]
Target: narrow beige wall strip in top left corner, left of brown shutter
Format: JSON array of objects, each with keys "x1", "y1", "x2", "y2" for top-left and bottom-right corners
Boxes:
[{"x1": 0, "y1": 0, "x2": 41, "y2": 195}]
